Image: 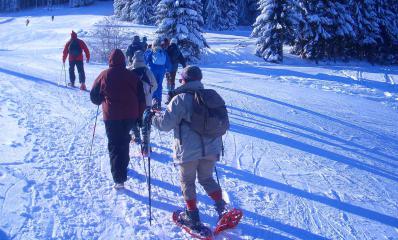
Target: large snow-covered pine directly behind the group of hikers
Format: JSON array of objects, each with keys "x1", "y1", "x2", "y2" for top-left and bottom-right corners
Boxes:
[{"x1": 156, "y1": 0, "x2": 208, "y2": 62}]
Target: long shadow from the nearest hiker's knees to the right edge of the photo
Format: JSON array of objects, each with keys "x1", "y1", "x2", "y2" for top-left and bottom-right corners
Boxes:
[{"x1": 218, "y1": 165, "x2": 398, "y2": 229}]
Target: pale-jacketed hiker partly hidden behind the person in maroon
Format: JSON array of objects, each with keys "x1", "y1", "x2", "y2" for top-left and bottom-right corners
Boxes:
[{"x1": 128, "y1": 51, "x2": 158, "y2": 156}]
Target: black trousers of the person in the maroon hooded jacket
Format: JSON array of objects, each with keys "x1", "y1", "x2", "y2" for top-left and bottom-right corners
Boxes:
[{"x1": 105, "y1": 119, "x2": 136, "y2": 183}]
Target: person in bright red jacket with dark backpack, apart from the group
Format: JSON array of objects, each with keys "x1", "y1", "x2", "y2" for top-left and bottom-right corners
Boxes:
[{"x1": 62, "y1": 31, "x2": 90, "y2": 90}]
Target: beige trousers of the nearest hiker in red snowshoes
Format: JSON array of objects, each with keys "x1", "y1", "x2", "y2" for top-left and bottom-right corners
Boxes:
[{"x1": 180, "y1": 155, "x2": 221, "y2": 201}]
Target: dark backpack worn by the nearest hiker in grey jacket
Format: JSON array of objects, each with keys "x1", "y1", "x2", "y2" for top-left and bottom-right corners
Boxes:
[{"x1": 183, "y1": 89, "x2": 229, "y2": 138}]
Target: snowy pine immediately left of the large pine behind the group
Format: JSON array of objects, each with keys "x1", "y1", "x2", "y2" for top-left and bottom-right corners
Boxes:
[{"x1": 130, "y1": 0, "x2": 156, "y2": 24}]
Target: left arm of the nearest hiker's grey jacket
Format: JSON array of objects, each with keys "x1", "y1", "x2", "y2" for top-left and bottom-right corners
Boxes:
[{"x1": 152, "y1": 96, "x2": 186, "y2": 132}]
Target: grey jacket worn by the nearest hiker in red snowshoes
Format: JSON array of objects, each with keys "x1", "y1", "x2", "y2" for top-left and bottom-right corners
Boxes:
[{"x1": 152, "y1": 81, "x2": 222, "y2": 164}]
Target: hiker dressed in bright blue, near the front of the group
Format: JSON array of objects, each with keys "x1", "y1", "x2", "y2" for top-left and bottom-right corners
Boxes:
[{"x1": 145, "y1": 38, "x2": 171, "y2": 109}]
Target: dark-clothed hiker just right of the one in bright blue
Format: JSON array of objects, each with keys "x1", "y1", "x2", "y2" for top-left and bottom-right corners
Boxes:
[{"x1": 166, "y1": 38, "x2": 187, "y2": 104}]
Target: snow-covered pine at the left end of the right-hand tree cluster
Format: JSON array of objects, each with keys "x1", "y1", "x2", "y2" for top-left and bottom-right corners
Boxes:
[{"x1": 252, "y1": 0, "x2": 297, "y2": 62}]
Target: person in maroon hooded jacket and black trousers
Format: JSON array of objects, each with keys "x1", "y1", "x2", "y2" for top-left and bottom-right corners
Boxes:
[{"x1": 90, "y1": 49, "x2": 145, "y2": 189}]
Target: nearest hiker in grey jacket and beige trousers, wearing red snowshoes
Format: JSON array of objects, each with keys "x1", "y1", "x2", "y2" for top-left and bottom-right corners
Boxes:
[{"x1": 148, "y1": 66, "x2": 226, "y2": 229}]
